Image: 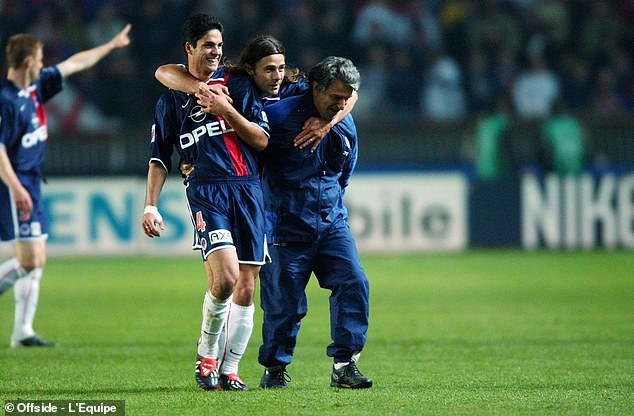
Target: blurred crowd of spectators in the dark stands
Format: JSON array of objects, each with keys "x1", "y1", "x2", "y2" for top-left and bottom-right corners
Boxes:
[{"x1": 0, "y1": 0, "x2": 634, "y2": 129}]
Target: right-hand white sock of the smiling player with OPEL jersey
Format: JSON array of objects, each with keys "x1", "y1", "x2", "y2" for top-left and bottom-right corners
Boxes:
[{"x1": 220, "y1": 303, "x2": 255, "y2": 374}]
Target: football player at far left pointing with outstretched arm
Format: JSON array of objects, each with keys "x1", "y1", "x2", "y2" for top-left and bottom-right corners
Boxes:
[{"x1": 0, "y1": 24, "x2": 131, "y2": 347}]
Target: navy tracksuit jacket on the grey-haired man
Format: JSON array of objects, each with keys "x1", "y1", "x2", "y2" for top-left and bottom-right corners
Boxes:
[{"x1": 261, "y1": 91, "x2": 358, "y2": 243}]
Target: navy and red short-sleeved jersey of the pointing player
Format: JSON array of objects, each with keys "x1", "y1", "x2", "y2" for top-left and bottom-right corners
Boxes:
[{"x1": 0, "y1": 67, "x2": 63, "y2": 173}]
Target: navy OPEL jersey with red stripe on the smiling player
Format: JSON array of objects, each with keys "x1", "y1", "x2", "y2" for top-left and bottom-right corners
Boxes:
[{"x1": 150, "y1": 67, "x2": 269, "y2": 181}]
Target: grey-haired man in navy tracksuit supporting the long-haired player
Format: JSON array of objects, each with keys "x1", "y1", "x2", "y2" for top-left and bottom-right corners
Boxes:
[{"x1": 259, "y1": 57, "x2": 372, "y2": 388}]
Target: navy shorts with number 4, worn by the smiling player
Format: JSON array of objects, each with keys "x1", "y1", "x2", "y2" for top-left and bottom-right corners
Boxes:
[{"x1": 186, "y1": 177, "x2": 269, "y2": 265}]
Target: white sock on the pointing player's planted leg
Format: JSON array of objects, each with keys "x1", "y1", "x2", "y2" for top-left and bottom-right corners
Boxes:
[{"x1": 13, "y1": 268, "x2": 42, "y2": 341}]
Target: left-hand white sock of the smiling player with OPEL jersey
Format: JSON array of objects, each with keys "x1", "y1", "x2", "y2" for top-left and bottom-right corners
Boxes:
[{"x1": 198, "y1": 291, "x2": 231, "y2": 358}]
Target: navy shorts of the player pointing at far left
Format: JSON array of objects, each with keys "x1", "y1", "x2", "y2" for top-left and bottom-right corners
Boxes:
[{"x1": 0, "y1": 173, "x2": 48, "y2": 242}]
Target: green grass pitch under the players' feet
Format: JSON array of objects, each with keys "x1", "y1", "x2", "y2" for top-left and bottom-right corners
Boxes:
[{"x1": 0, "y1": 251, "x2": 634, "y2": 415}]
